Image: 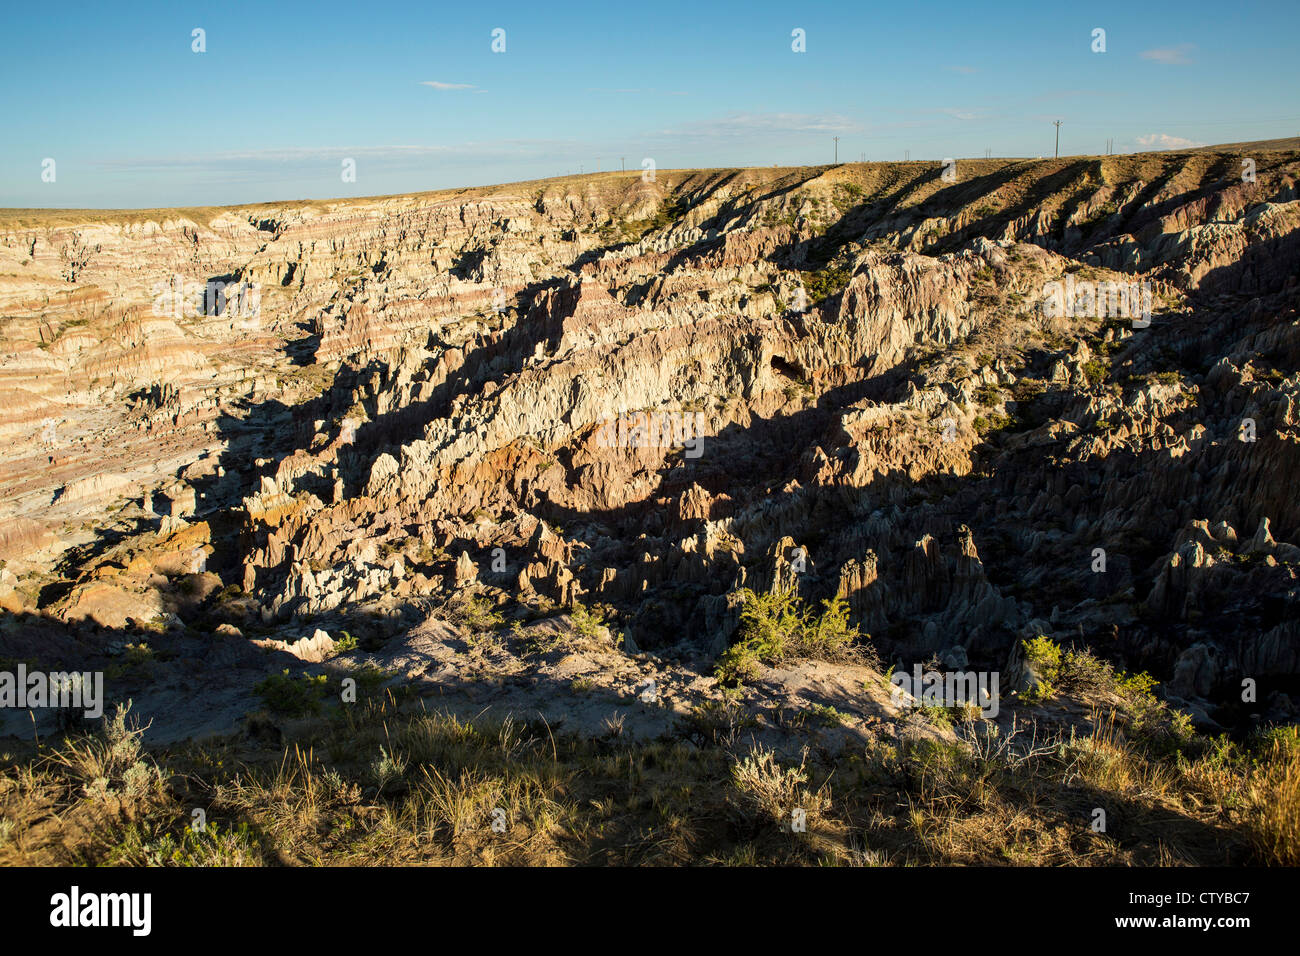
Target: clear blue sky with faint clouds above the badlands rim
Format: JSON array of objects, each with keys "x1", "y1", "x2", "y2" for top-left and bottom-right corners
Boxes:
[{"x1": 0, "y1": 0, "x2": 1300, "y2": 208}]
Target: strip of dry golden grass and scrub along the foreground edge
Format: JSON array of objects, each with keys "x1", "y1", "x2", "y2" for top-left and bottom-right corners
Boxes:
[{"x1": 0, "y1": 692, "x2": 1300, "y2": 866}]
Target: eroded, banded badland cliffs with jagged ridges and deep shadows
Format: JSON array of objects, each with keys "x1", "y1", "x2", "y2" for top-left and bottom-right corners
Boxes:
[{"x1": 0, "y1": 153, "x2": 1300, "y2": 723}]
